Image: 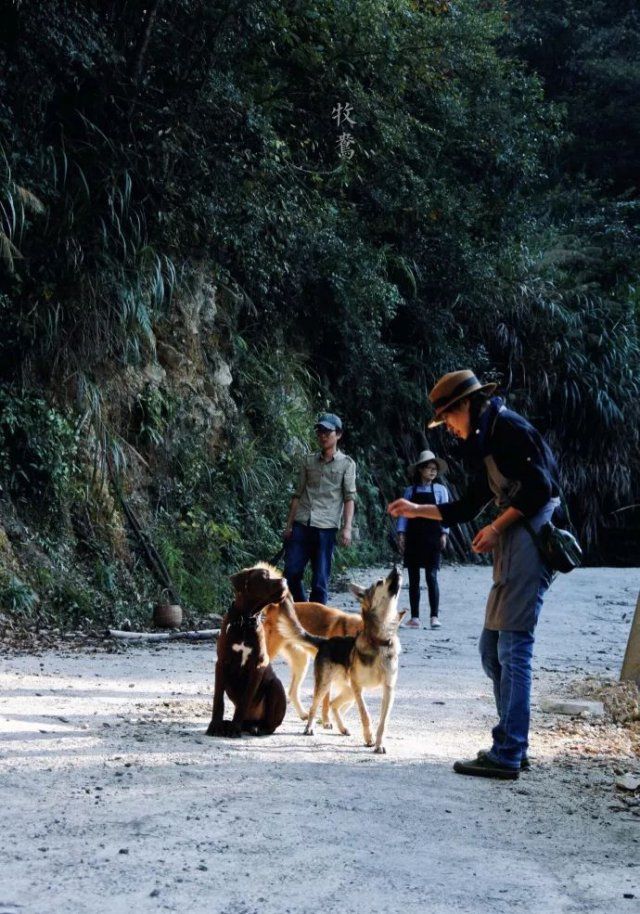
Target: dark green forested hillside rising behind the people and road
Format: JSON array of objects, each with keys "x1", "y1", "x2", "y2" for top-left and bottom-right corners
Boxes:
[{"x1": 0, "y1": 0, "x2": 640, "y2": 626}]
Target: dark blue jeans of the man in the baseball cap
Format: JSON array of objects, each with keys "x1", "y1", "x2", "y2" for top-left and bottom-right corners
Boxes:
[{"x1": 284, "y1": 522, "x2": 338, "y2": 603}]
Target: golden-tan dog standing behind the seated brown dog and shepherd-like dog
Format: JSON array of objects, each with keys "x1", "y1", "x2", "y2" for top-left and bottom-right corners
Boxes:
[{"x1": 262, "y1": 603, "x2": 362, "y2": 723}]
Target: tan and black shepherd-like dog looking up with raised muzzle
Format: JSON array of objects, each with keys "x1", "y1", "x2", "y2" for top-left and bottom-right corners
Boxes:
[{"x1": 304, "y1": 566, "x2": 404, "y2": 753}]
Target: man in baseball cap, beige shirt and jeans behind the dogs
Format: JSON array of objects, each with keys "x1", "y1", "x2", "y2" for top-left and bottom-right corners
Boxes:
[{"x1": 283, "y1": 413, "x2": 356, "y2": 603}]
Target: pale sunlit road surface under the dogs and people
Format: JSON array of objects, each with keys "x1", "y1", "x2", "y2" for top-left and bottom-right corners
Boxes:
[{"x1": 0, "y1": 567, "x2": 640, "y2": 914}]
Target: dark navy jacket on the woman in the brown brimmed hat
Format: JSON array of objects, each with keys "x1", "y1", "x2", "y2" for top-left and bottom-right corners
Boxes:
[{"x1": 438, "y1": 397, "x2": 560, "y2": 524}]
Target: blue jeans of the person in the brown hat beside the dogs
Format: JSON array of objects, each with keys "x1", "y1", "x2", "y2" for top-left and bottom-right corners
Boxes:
[{"x1": 480, "y1": 572, "x2": 550, "y2": 769}]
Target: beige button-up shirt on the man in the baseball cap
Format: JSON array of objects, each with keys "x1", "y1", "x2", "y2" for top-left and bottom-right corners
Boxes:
[{"x1": 295, "y1": 451, "x2": 356, "y2": 530}]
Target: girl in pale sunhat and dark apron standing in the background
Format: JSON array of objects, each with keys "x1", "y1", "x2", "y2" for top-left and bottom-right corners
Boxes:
[{"x1": 396, "y1": 451, "x2": 449, "y2": 628}]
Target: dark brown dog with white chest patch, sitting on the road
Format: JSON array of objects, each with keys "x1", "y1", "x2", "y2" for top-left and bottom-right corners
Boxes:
[{"x1": 207, "y1": 563, "x2": 323, "y2": 736}]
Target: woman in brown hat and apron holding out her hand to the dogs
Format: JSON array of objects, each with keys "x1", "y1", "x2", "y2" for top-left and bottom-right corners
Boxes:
[{"x1": 388, "y1": 371, "x2": 560, "y2": 780}]
